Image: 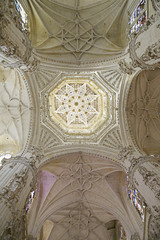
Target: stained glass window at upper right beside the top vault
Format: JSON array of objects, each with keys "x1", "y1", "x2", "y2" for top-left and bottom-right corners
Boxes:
[{"x1": 129, "y1": 0, "x2": 147, "y2": 35}]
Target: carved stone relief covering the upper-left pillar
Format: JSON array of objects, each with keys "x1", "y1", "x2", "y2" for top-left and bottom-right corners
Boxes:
[{"x1": 0, "y1": 0, "x2": 39, "y2": 71}]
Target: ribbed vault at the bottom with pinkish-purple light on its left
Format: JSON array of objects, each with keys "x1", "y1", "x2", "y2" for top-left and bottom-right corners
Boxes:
[{"x1": 29, "y1": 153, "x2": 136, "y2": 240}]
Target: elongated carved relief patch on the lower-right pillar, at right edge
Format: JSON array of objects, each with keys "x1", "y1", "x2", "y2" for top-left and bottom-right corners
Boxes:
[{"x1": 138, "y1": 166, "x2": 160, "y2": 200}]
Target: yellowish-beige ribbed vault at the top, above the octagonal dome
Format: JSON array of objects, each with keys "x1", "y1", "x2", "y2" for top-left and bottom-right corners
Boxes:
[{"x1": 27, "y1": 0, "x2": 128, "y2": 64}]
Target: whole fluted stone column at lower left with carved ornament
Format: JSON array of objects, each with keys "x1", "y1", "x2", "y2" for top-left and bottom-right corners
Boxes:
[{"x1": 0, "y1": 148, "x2": 40, "y2": 240}]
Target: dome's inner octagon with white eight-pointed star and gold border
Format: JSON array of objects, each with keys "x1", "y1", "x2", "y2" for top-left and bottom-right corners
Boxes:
[{"x1": 49, "y1": 78, "x2": 108, "y2": 134}]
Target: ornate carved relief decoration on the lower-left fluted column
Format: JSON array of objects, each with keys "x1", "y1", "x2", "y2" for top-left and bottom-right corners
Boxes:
[{"x1": 0, "y1": 146, "x2": 43, "y2": 240}]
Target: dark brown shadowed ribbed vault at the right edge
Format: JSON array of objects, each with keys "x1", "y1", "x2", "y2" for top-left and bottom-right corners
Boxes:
[{"x1": 126, "y1": 69, "x2": 160, "y2": 155}]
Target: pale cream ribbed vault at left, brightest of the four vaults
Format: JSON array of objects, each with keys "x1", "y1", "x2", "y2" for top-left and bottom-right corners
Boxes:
[{"x1": 0, "y1": 67, "x2": 31, "y2": 155}]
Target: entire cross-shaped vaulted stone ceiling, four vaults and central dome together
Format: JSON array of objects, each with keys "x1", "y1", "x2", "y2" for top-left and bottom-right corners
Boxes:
[{"x1": 0, "y1": 0, "x2": 160, "y2": 240}]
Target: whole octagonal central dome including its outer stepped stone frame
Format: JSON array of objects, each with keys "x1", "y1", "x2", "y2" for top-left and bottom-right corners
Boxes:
[{"x1": 41, "y1": 73, "x2": 116, "y2": 142}]
